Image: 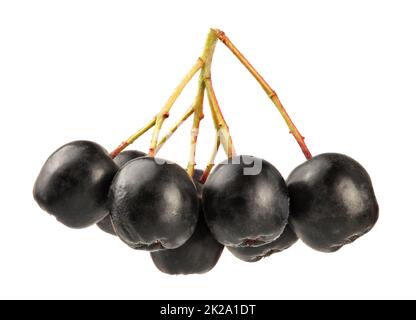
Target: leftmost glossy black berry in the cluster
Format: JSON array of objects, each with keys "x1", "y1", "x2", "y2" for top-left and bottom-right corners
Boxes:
[{"x1": 33, "y1": 141, "x2": 118, "y2": 228}]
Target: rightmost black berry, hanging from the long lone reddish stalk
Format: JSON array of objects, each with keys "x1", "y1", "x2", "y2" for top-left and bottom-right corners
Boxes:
[{"x1": 287, "y1": 153, "x2": 378, "y2": 252}]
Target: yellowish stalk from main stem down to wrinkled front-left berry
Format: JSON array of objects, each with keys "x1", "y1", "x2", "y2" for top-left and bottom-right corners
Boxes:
[{"x1": 149, "y1": 58, "x2": 204, "y2": 157}]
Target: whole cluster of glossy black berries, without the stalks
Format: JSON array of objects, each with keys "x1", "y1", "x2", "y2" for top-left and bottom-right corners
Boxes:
[{"x1": 33, "y1": 141, "x2": 378, "y2": 274}]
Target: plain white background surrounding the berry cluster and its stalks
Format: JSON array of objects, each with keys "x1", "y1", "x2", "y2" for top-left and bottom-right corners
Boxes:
[{"x1": 0, "y1": 0, "x2": 416, "y2": 299}]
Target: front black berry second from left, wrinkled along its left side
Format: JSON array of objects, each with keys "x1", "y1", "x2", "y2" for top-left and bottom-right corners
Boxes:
[{"x1": 109, "y1": 157, "x2": 199, "y2": 251}]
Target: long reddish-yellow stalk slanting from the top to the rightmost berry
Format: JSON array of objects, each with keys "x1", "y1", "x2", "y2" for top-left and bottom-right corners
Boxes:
[{"x1": 214, "y1": 29, "x2": 312, "y2": 160}]
